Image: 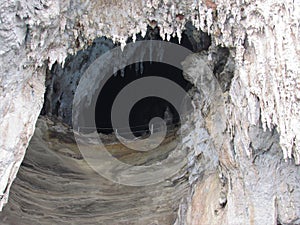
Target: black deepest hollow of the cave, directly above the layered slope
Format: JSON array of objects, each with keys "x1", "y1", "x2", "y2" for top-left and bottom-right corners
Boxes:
[{"x1": 95, "y1": 62, "x2": 192, "y2": 137}]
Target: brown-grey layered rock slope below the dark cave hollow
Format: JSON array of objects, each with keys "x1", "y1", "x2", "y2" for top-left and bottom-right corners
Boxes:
[{"x1": 0, "y1": 117, "x2": 188, "y2": 225}]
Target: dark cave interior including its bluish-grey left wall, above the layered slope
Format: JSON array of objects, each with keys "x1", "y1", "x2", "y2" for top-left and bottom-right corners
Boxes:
[{"x1": 41, "y1": 23, "x2": 211, "y2": 136}]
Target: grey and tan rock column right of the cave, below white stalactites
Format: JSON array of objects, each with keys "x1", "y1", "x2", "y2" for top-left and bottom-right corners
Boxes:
[{"x1": 177, "y1": 54, "x2": 300, "y2": 225}]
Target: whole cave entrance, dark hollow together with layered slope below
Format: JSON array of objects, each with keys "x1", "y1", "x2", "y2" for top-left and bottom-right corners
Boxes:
[{"x1": 0, "y1": 22, "x2": 237, "y2": 224}]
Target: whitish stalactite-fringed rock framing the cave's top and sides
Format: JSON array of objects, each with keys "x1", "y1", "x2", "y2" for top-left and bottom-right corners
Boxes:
[{"x1": 0, "y1": 0, "x2": 300, "y2": 220}]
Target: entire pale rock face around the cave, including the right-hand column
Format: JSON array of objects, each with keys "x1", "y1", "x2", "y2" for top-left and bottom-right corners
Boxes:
[{"x1": 0, "y1": 0, "x2": 300, "y2": 224}]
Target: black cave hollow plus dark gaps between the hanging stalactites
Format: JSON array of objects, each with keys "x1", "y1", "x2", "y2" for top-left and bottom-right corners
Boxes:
[{"x1": 95, "y1": 24, "x2": 203, "y2": 136}]
